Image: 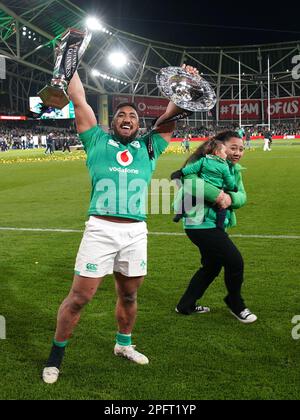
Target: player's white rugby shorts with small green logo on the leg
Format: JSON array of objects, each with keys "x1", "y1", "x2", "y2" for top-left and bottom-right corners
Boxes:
[{"x1": 75, "y1": 216, "x2": 148, "y2": 278}]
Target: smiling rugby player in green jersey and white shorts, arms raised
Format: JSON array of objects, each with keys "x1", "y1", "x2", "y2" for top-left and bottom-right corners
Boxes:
[{"x1": 43, "y1": 66, "x2": 198, "y2": 384}]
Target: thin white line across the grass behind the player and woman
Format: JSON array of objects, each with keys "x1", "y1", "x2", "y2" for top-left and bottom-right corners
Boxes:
[{"x1": 0, "y1": 227, "x2": 300, "y2": 239}]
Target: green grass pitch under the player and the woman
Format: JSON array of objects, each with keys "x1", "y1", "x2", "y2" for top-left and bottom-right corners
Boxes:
[{"x1": 0, "y1": 141, "x2": 300, "y2": 400}]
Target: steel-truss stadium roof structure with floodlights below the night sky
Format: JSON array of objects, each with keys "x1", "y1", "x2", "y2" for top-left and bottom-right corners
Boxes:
[{"x1": 0, "y1": 0, "x2": 300, "y2": 116}]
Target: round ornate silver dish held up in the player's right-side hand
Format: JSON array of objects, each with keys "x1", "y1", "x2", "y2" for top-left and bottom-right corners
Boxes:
[{"x1": 156, "y1": 67, "x2": 217, "y2": 112}]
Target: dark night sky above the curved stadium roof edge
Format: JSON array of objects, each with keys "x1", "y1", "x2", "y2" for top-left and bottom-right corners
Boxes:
[{"x1": 72, "y1": 0, "x2": 300, "y2": 46}]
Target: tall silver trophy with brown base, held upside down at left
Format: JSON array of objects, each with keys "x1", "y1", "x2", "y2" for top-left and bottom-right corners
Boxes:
[{"x1": 38, "y1": 28, "x2": 92, "y2": 109}]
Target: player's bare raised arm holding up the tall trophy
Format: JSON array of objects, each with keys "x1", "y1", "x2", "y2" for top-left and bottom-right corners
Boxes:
[{"x1": 68, "y1": 72, "x2": 97, "y2": 133}]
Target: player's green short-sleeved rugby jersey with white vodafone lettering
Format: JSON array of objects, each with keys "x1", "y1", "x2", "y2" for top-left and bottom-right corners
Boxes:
[{"x1": 79, "y1": 126, "x2": 168, "y2": 221}]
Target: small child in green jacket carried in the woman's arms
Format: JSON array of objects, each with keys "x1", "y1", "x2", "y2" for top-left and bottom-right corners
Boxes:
[{"x1": 171, "y1": 140, "x2": 237, "y2": 229}]
